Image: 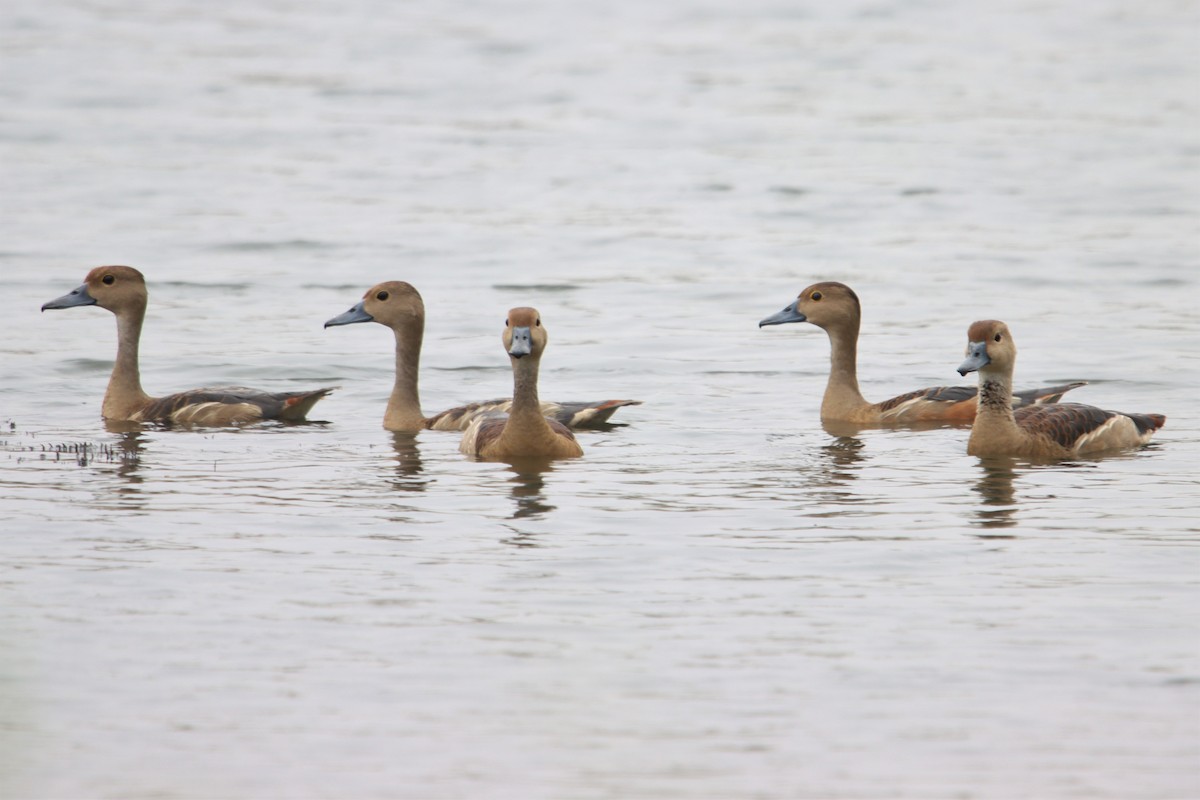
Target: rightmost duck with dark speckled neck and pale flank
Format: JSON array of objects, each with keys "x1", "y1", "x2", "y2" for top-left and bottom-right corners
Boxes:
[{"x1": 959, "y1": 319, "x2": 1166, "y2": 459}]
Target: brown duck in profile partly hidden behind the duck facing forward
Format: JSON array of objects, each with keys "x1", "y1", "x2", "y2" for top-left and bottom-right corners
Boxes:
[{"x1": 325, "y1": 281, "x2": 641, "y2": 433}]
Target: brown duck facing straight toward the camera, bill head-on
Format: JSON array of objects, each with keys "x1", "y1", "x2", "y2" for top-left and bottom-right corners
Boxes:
[{"x1": 458, "y1": 307, "x2": 583, "y2": 459}]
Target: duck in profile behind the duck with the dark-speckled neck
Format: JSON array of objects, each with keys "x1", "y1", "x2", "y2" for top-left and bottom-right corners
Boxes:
[{"x1": 758, "y1": 281, "x2": 1086, "y2": 426}]
